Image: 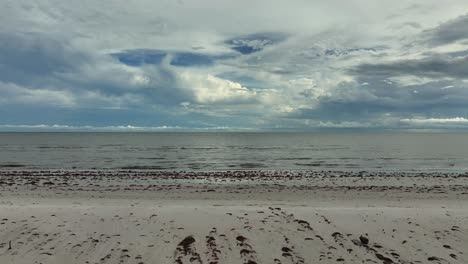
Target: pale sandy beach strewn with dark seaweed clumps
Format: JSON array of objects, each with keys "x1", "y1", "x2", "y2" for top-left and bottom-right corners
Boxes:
[{"x1": 0, "y1": 170, "x2": 468, "y2": 264}]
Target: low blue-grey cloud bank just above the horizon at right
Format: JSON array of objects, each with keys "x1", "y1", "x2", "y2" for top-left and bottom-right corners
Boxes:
[{"x1": 290, "y1": 78, "x2": 468, "y2": 122}]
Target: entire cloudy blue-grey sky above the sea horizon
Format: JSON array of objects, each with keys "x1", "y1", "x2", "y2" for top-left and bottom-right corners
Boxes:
[{"x1": 0, "y1": 0, "x2": 468, "y2": 131}]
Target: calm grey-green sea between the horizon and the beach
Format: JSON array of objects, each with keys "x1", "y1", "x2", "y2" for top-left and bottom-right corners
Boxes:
[{"x1": 0, "y1": 133, "x2": 468, "y2": 172}]
